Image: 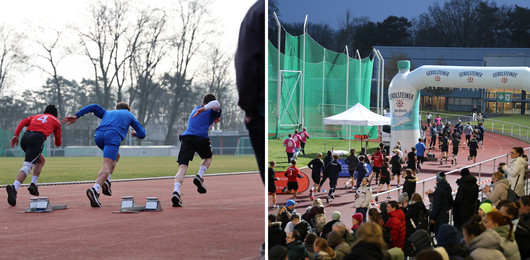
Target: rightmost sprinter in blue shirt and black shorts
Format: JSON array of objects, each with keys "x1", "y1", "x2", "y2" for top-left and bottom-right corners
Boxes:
[{"x1": 171, "y1": 94, "x2": 221, "y2": 207}]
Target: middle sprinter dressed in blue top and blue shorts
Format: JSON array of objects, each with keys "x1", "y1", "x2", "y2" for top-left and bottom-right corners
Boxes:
[{"x1": 61, "y1": 102, "x2": 145, "y2": 207}]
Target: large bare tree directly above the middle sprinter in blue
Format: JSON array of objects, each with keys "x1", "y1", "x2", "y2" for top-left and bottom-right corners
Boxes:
[{"x1": 77, "y1": 0, "x2": 128, "y2": 108}]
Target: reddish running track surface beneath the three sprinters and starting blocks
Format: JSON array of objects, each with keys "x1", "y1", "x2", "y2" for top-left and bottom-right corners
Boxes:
[{"x1": 0, "y1": 174, "x2": 265, "y2": 259}]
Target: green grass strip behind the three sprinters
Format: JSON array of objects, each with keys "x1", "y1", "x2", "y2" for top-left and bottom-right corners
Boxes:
[{"x1": 0, "y1": 155, "x2": 258, "y2": 185}]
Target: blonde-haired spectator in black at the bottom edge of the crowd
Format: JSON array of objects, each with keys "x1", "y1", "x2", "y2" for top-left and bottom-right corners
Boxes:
[{"x1": 344, "y1": 222, "x2": 390, "y2": 260}]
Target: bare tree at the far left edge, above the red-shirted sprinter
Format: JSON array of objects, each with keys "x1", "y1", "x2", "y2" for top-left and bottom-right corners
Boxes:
[{"x1": 0, "y1": 24, "x2": 29, "y2": 93}]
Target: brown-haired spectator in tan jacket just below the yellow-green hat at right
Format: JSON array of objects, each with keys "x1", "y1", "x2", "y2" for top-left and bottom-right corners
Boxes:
[{"x1": 483, "y1": 211, "x2": 521, "y2": 260}]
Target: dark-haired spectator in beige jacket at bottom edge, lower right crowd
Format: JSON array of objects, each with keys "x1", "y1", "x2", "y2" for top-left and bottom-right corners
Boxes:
[{"x1": 462, "y1": 215, "x2": 505, "y2": 260}]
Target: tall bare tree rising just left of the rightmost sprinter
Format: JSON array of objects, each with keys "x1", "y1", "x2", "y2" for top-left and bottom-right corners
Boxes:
[{"x1": 164, "y1": 0, "x2": 213, "y2": 144}]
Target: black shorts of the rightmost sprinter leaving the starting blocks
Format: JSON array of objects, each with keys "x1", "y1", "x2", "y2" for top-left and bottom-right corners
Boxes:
[{"x1": 177, "y1": 135, "x2": 213, "y2": 165}]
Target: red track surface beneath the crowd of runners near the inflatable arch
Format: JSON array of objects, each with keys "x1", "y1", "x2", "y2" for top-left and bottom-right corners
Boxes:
[{"x1": 268, "y1": 132, "x2": 529, "y2": 226}]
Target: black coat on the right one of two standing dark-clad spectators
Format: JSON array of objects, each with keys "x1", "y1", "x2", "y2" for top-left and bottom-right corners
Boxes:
[{"x1": 453, "y1": 175, "x2": 479, "y2": 229}]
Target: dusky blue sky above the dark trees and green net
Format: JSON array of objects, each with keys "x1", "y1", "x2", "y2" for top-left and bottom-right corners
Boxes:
[{"x1": 277, "y1": 0, "x2": 530, "y2": 28}]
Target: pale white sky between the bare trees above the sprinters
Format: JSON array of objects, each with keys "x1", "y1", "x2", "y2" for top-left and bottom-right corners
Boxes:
[{"x1": 0, "y1": 0, "x2": 256, "y2": 93}]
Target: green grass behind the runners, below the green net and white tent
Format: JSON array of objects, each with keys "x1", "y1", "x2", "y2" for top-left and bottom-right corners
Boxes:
[{"x1": 268, "y1": 139, "x2": 368, "y2": 171}]
